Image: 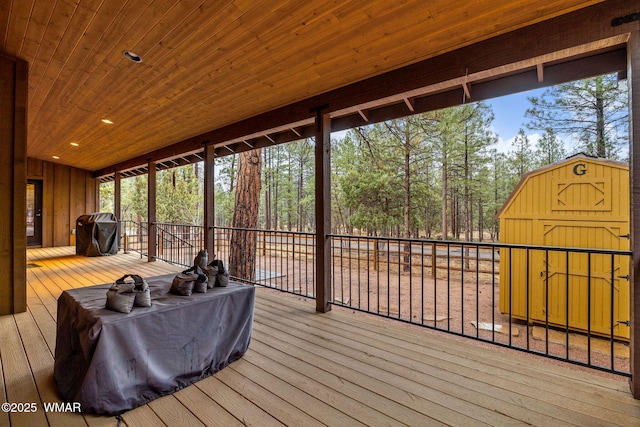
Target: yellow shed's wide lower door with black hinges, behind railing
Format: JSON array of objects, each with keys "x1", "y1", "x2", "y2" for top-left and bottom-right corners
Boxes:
[{"x1": 531, "y1": 223, "x2": 630, "y2": 340}]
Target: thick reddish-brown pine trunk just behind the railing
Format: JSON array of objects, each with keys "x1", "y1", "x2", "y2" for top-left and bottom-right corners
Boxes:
[{"x1": 229, "y1": 149, "x2": 262, "y2": 280}]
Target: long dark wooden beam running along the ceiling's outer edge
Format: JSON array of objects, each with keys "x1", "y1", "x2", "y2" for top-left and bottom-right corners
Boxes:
[{"x1": 94, "y1": 0, "x2": 640, "y2": 177}]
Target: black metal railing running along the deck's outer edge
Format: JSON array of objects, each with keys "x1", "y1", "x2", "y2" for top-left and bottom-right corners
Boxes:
[{"x1": 119, "y1": 224, "x2": 631, "y2": 376}]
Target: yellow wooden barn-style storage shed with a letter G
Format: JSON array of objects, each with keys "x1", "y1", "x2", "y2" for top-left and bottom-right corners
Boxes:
[{"x1": 498, "y1": 154, "x2": 630, "y2": 340}]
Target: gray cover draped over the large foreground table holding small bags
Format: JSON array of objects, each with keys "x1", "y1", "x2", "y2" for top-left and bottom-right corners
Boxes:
[{"x1": 54, "y1": 275, "x2": 255, "y2": 415}]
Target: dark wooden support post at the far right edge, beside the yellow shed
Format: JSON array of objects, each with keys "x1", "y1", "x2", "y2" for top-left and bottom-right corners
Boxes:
[{"x1": 627, "y1": 31, "x2": 640, "y2": 399}]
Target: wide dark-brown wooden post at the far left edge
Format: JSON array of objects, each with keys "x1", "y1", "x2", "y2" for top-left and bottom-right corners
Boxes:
[{"x1": 0, "y1": 53, "x2": 29, "y2": 315}]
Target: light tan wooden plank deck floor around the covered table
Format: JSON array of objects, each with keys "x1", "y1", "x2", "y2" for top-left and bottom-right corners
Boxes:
[{"x1": 0, "y1": 248, "x2": 640, "y2": 427}]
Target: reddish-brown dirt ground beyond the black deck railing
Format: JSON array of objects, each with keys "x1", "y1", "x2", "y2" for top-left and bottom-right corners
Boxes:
[{"x1": 258, "y1": 252, "x2": 629, "y2": 372}]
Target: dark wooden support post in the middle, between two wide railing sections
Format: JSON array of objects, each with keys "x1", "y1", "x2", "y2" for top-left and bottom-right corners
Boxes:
[{"x1": 313, "y1": 106, "x2": 331, "y2": 313}]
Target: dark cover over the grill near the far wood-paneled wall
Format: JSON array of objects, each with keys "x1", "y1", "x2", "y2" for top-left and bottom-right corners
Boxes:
[{"x1": 76, "y1": 213, "x2": 118, "y2": 256}]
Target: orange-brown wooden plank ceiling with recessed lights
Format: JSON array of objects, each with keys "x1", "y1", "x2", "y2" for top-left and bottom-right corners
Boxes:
[{"x1": 0, "y1": 0, "x2": 600, "y2": 171}]
